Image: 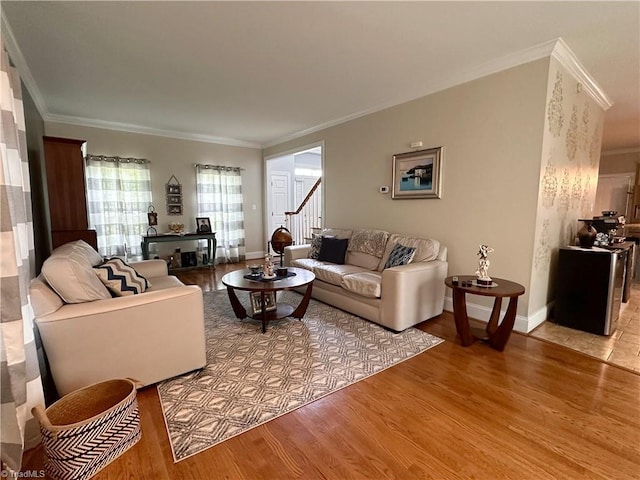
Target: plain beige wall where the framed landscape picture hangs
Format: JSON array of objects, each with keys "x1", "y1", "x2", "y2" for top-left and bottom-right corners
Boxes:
[{"x1": 264, "y1": 59, "x2": 549, "y2": 328}]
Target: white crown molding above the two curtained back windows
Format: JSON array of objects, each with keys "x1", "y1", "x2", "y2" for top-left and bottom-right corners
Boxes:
[{"x1": 43, "y1": 113, "x2": 262, "y2": 149}]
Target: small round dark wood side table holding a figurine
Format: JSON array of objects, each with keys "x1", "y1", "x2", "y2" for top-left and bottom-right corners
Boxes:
[{"x1": 444, "y1": 275, "x2": 524, "y2": 352}]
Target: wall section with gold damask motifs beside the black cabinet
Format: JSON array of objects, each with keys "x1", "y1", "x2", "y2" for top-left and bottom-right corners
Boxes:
[{"x1": 529, "y1": 57, "x2": 604, "y2": 315}]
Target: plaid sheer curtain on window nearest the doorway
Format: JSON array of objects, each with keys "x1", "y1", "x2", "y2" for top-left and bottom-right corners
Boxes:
[{"x1": 196, "y1": 165, "x2": 246, "y2": 263}]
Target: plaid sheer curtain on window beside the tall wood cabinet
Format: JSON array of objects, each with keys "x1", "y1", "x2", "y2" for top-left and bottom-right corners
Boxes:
[{"x1": 85, "y1": 155, "x2": 151, "y2": 257}]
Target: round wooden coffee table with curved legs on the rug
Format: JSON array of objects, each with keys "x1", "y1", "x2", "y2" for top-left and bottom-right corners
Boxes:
[{"x1": 222, "y1": 267, "x2": 316, "y2": 333}]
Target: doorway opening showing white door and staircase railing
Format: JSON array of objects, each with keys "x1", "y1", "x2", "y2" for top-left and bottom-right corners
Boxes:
[{"x1": 264, "y1": 142, "x2": 324, "y2": 248}]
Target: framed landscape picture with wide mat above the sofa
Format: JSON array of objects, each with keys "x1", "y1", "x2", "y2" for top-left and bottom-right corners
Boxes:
[{"x1": 391, "y1": 147, "x2": 443, "y2": 200}]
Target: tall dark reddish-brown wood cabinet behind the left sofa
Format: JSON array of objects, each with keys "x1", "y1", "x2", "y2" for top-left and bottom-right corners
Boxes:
[{"x1": 43, "y1": 137, "x2": 98, "y2": 249}]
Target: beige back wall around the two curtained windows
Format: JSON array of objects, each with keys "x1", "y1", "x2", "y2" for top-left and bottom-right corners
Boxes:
[{"x1": 45, "y1": 122, "x2": 265, "y2": 257}]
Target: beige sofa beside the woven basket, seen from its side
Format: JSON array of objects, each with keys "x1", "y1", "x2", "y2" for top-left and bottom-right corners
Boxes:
[{"x1": 30, "y1": 240, "x2": 206, "y2": 395}]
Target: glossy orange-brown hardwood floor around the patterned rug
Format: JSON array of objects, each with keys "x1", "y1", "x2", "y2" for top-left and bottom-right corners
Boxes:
[{"x1": 24, "y1": 265, "x2": 640, "y2": 480}]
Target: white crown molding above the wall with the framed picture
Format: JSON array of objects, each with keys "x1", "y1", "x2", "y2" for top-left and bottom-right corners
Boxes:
[{"x1": 263, "y1": 39, "x2": 557, "y2": 148}]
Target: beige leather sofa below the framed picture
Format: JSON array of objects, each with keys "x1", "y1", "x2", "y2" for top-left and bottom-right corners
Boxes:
[{"x1": 284, "y1": 229, "x2": 448, "y2": 331}]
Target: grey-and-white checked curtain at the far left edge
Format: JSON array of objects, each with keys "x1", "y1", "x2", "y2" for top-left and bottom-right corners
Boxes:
[{"x1": 0, "y1": 40, "x2": 44, "y2": 472}]
